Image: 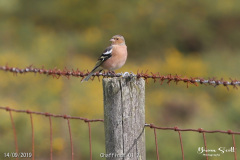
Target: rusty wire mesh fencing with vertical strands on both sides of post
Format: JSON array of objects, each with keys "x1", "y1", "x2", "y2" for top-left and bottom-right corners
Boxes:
[{"x1": 0, "y1": 106, "x2": 240, "y2": 160}]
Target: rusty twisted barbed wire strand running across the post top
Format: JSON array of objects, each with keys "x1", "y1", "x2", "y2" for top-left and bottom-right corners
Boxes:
[{"x1": 0, "y1": 65, "x2": 240, "y2": 90}]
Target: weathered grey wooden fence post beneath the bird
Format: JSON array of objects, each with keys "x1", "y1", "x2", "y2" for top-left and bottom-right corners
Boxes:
[{"x1": 103, "y1": 77, "x2": 146, "y2": 160}]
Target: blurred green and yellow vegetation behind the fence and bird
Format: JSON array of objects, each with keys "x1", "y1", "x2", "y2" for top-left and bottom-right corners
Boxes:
[{"x1": 0, "y1": 0, "x2": 240, "y2": 160}]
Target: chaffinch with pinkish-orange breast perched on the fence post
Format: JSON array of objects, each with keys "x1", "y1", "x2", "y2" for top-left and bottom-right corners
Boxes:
[{"x1": 82, "y1": 35, "x2": 127, "y2": 82}]
